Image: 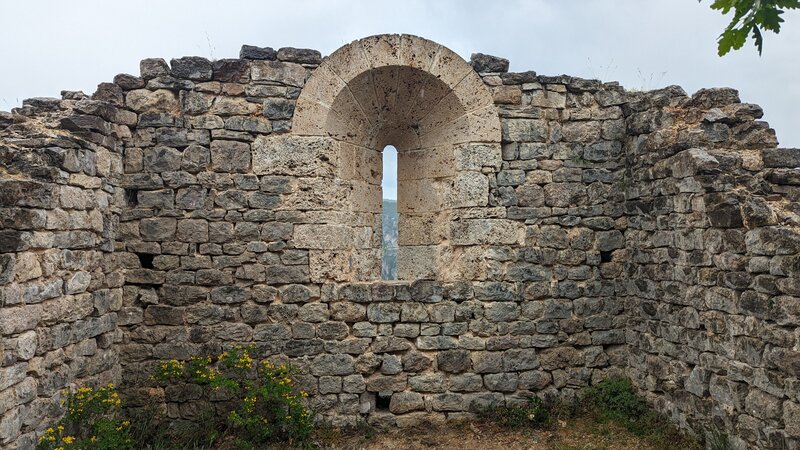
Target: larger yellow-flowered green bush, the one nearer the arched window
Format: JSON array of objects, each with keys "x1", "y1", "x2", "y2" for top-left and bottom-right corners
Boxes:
[{"x1": 154, "y1": 346, "x2": 313, "y2": 448}]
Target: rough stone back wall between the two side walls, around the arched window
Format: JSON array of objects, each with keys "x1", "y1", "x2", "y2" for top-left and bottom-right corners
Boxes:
[{"x1": 112, "y1": 35, "x2": 626, "y2": 425}]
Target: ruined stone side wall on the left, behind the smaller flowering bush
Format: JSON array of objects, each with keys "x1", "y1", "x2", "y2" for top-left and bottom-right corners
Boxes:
[{"x1": 0, "y1": 92, "x2": 126, "y2": 448}]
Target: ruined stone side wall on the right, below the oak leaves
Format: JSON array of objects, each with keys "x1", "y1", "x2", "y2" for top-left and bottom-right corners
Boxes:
[{"x1": 624, "y1": 88, "x2": 800, "y2": 448}]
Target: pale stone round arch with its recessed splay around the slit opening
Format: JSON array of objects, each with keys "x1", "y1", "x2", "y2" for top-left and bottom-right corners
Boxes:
[{"x1": 292, "y1": 35, "x2": 501, "y2": 280}]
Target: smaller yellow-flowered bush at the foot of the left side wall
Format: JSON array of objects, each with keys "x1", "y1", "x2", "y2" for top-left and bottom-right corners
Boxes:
[{"x1": 36, "y1": 384, "x2": 134, "y2": 450}]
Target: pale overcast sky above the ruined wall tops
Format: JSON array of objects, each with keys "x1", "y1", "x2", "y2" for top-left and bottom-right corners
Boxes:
[{"x1": 0, "y1": 0, "x2": 800, "y2": 200}]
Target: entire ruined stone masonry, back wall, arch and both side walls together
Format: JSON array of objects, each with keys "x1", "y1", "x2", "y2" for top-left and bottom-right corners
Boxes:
[{"x1": 0, "y1": 35, "x2": 800, "y2": 449}]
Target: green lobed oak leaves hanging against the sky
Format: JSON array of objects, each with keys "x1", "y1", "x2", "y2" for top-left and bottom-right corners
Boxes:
[{"x1": 699, "y1": 0, "x2": 800, "y2": 56}]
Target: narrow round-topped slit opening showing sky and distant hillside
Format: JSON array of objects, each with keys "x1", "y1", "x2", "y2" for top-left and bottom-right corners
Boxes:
[{"x1": 381, "y1": 145, "x2": 398, "y2": 280}]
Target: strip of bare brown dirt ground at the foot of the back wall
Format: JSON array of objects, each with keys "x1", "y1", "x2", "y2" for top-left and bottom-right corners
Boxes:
[{"x1": 320, "y1": 418, "x2": 668, "y2": 450}]
